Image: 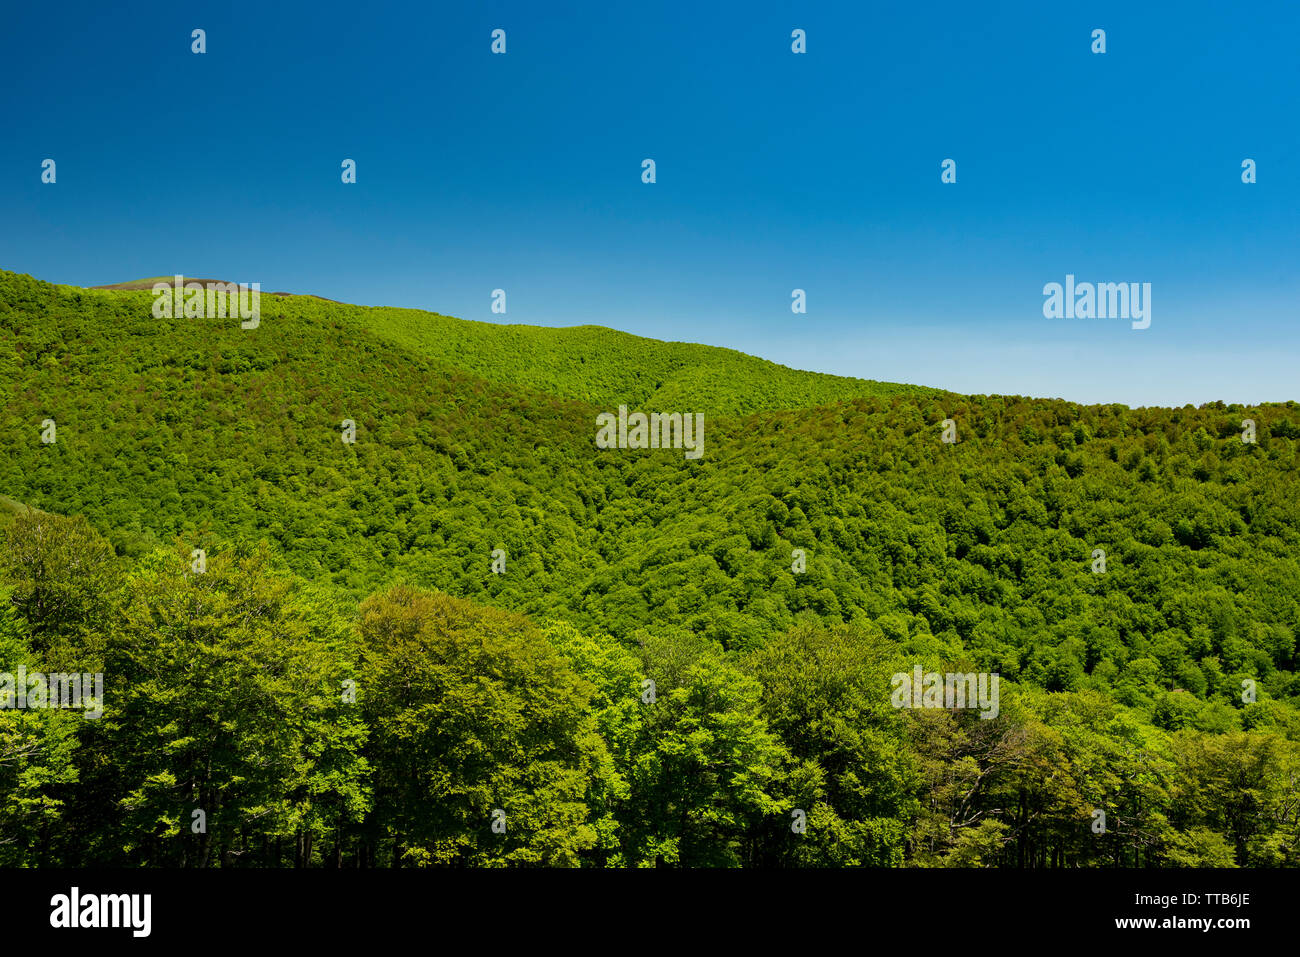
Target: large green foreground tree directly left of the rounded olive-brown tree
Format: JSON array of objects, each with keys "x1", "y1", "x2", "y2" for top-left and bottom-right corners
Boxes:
[{"x1": 98, "y1": 546, "x2": 367, "y2": 867}]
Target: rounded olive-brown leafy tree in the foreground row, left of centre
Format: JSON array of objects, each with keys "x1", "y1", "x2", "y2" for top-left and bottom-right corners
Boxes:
[{"x1": 360, "y1": 586, "x2": 616, "y2": 866}]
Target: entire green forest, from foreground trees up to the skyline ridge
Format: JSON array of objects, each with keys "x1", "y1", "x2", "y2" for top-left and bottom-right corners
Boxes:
[{"x1": 0, "y1": 272, "x2": 1300, "y2": 867}]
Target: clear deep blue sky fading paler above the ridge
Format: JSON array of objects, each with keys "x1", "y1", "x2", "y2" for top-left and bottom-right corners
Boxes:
[{"x1": 0, "y1": 0, "x2": 1300, "y2": 406}]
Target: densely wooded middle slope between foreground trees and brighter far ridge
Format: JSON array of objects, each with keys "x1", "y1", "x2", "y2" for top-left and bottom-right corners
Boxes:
[{"x1": 0, "y1": 265, "x2": 1300, "y2": 694}]
